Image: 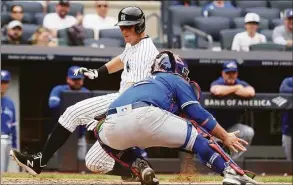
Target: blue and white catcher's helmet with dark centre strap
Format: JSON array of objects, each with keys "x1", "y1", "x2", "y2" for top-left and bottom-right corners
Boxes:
[{"x1": 151, "y1": 51, "x2": 189, "y2": 81}]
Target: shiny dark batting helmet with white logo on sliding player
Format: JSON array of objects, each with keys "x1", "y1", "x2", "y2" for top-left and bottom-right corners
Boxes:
[{"x1": 115, "y1": 6, "x2": 145, "y2": 33}]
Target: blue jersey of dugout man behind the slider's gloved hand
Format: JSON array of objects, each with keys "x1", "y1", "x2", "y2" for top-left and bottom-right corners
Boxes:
[{"x1": 48, "y1": 85, "x2": 89, "y2": 108}]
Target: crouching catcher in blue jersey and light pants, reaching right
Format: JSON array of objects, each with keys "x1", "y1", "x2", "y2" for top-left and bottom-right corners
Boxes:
[{"x1": 98, "y1": 51, "x2": 257, "y2": 185}]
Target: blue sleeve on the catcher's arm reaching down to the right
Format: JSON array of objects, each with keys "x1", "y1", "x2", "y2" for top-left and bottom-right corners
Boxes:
[{"x1": 175, "y1": 77, "x2": 217, "y2": 132}]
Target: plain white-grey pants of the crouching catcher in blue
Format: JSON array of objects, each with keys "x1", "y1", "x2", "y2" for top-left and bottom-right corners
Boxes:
[{"x1": 99, "y1": 106, "x2": 198, "y2": 151}]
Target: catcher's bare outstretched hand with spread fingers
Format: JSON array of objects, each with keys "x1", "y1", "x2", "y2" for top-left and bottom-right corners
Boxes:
[{"x1": 223, "y1": 130, "x2": 248, "y2": 153}]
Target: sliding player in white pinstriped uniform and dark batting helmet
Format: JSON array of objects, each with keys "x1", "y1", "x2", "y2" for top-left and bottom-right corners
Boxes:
[{"x1": 10, "y1": 7, "x2": 159, "y2": 181}]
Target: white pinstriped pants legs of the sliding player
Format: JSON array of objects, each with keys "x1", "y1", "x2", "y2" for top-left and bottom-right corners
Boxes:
[{"x1": 58, "y1": 93, "x2": 120, "y2": 173}]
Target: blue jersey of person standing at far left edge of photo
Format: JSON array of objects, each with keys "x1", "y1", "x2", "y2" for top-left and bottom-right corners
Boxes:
[{"x1": 1, "y1": 96, "x2": 17, "y2": 148}]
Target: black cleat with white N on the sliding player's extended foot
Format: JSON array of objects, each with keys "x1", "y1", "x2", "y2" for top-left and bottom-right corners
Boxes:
[{"x1": 9, "y1": 150, "x2": 46, "y2": 176}]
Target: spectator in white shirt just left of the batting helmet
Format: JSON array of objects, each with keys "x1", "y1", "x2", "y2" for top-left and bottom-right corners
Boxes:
[{"x1": 82, "y1": 1, "x2": 118, "y2": 38}]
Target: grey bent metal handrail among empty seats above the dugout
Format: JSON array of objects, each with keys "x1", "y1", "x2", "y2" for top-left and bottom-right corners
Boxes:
[{"x1": 180, "y1": 25, "x2": 214, "y2": 49}]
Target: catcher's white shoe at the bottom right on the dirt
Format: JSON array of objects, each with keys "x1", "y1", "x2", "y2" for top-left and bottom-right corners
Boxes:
[{"x1": 223, "y1": 166, "x2": 258, "y2": 185}]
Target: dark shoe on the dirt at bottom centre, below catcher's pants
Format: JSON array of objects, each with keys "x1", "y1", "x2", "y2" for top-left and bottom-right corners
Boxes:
[{"x1": 132, "y1": 158, "x2": 159, "y2": 185}]
